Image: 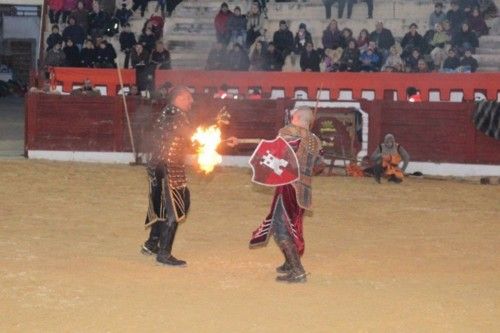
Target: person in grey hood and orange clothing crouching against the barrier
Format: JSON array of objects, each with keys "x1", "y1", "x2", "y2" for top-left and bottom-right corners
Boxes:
[{"x1": 371, "y1": 134, "x2": 410, "y2": 184}]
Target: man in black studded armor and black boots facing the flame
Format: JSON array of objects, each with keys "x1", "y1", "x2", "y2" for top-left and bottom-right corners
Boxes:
[{"x1": 141, "y1": 87, "x2": 194, "y2": 266}]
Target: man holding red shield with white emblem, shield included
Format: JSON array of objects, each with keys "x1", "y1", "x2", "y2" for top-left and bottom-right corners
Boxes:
[{"x1": 232, "y1": 106, "x2": 321, "y2": 283}]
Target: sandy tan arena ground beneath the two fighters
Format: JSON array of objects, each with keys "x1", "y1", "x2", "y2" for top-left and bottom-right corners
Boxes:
[{"x1": 0, "y1": 160, "x2": 500, "y2": 332}]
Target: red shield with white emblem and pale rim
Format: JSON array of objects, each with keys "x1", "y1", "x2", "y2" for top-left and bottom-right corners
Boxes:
[{"x1": 249, "y1": 136, "x2": 299, "y2": 186}]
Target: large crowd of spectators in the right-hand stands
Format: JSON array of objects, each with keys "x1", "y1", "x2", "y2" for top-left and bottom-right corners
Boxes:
[{"x1": 206, "y1": 0, "x2": 496, "y2": 73}]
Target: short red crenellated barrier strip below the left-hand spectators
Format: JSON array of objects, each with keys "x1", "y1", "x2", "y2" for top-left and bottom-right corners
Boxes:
[{"x1": 52, "y1": 67, "x2": 135, "y2": 96}]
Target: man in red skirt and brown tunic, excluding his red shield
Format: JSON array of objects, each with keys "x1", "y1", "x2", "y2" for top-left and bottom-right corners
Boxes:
[{"x1": 250, "y1": 107, "x2": 321, "y2": 283}]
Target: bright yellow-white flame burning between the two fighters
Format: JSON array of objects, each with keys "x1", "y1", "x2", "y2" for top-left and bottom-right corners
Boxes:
[{"x1": 191, "y1": 125, "x2": 222, "y2": 174}]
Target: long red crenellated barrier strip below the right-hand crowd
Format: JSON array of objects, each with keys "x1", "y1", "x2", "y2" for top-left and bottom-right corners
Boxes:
[{"x1": 155, "y1": 70, "x2": 500, "y2": 101}]
